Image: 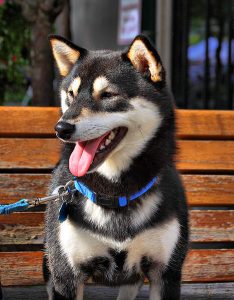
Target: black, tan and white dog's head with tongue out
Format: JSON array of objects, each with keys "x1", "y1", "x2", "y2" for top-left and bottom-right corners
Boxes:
[{"x1": 50, "y1": 35, "x2": 172, "y2": 179}]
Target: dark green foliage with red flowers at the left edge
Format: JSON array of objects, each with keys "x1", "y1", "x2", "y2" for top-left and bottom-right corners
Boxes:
[{"x1": 0, "y1": 1, "x2": 30, "y2": 104}]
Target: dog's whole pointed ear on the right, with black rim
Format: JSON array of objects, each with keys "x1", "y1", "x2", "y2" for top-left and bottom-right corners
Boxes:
[{"x1": 124, "y1": 35, "x2": 165, "y2": 83}]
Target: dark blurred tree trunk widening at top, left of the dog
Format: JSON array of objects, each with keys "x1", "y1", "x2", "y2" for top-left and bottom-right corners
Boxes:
[{"x1": 14, "y1": 0, "x2": 66, "y2": 106}]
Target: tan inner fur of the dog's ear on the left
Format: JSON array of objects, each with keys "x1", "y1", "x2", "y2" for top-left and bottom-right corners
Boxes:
[{"x1": 50, "y1": 39, "x2": 80, "y2": 76}]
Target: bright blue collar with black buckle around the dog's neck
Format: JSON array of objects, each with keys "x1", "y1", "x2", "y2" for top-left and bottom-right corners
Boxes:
[{"x1": 74, "y1": 177, "x2": 157, "y2": 208}]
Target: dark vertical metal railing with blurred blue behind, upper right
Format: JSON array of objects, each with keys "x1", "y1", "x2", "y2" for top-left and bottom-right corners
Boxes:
[{"x1": 172, "y1": 0, "x2": 234, "y2": 109}]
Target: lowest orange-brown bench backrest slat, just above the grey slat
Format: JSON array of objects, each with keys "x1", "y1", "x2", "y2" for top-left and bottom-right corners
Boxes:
[{"x1": 0, "y1": 249, "x2": 234, "y2": 286}]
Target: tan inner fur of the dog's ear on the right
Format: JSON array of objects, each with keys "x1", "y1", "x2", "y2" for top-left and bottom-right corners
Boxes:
[{"x1": 127, "y1": 40, "x2": 162, "y2": 82}]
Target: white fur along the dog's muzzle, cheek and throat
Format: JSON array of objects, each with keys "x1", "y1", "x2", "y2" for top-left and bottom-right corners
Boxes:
[{"x1": 68, "y1": 97, "x2": 162, "y2": 180}]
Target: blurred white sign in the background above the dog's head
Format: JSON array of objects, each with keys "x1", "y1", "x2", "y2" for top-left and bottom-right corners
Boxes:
[{"x1": 118, "y1": 0, "x2": 141, "y2": 45}]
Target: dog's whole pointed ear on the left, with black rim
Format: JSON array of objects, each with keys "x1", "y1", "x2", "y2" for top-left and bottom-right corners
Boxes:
[{"x1": 49, "y1": 35, "x2": 86, "y2": 76}]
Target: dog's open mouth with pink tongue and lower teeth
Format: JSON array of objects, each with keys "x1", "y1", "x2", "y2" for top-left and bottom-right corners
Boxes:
[{"x1": 69, "y1": 127, "x2": 128, "y2": 177}]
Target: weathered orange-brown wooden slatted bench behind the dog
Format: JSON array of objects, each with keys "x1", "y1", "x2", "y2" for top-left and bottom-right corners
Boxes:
[{"x1": 0, "y1": 107, "x2": 234, "y2": 300}]
